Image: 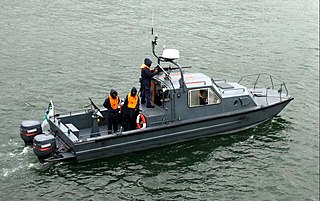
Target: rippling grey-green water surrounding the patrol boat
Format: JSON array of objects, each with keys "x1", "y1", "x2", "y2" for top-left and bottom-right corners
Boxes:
[{"x1": 0, "y1": 0, "x2": 319, "y2": 200}]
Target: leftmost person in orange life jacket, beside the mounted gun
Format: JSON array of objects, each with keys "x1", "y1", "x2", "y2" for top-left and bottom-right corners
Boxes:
[{"x1": 103, "y1": 89, "x2": 120, "y2": 134}]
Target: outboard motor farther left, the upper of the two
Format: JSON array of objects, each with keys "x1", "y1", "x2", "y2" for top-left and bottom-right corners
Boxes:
[{"x1": 20, "y1": 120, "x2": 42, "y2": 146}]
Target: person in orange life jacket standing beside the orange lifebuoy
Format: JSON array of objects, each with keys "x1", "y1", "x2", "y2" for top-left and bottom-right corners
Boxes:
[{"x1": 123, "y1": 87, "x2": 140, "y2": 131}]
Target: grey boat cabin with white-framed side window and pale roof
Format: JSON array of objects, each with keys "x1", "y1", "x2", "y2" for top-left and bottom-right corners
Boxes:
[{"x1": 141, "y1": 50, "x2": 256, "y2": 127}]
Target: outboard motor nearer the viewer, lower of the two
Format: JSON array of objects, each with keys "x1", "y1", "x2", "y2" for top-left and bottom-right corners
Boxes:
[{"x1": 33, "y1": 133, "x2": 57, "y2": 163}]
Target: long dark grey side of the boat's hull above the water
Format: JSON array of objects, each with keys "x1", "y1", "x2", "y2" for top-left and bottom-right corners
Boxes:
[{"x1": 73, "y1": 98, "x2": 293, "y2": 162}]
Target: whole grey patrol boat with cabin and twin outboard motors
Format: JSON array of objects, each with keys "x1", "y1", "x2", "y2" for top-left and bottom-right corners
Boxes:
[{"x1": 20, "y1": 37, "x2": 293, "y2": 162}]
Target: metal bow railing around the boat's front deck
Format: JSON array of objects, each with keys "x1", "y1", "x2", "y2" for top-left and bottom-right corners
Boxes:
[{"x1": 238, "y1": 73, "x2": 289, "y2": 100}]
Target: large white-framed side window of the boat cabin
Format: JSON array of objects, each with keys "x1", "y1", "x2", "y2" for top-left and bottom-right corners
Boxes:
[{"x1": 188, "y1": 88, "x2": 221, "y2": 107}]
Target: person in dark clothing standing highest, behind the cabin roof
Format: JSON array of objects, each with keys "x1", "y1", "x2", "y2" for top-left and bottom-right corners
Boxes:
[{"x1": 140, "y1": 58, "x2": 158, "y2": 108}]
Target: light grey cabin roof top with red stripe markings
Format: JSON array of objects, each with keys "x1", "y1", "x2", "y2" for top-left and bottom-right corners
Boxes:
[{"x1": 154, "y1": 72, "x2": 213, "y2": 89}]
